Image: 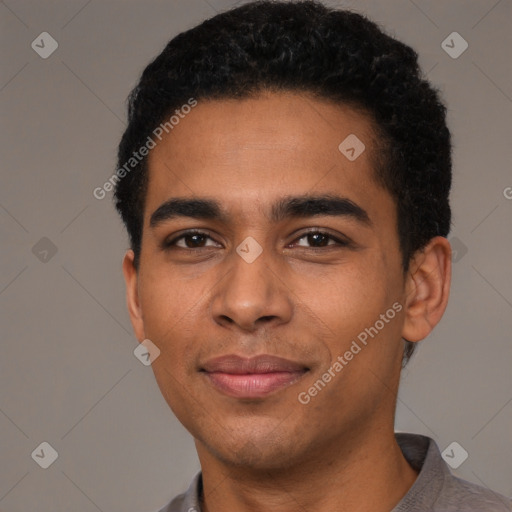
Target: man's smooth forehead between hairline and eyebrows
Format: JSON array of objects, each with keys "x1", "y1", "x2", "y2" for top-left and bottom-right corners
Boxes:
[{"x1": 145, "y1": 93, "x2": 390, "y2": 224}]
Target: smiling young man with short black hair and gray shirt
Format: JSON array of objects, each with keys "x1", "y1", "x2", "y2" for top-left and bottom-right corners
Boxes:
[{"x1": 115, "y1": 2, "x2": 510, "y2": 512}]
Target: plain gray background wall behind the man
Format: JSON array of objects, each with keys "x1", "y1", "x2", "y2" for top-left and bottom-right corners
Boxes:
[{"x1": 0, "y1": 0, "x2": 512, "y2": 512}]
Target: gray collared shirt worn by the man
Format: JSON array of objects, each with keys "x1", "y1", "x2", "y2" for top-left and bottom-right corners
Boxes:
[{"x1": 158, "y1": 433, "x2": 512, "y2": 512}]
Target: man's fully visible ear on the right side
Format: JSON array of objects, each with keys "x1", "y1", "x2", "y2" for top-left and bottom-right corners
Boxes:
[{"x1": 402, "y1": 236, "x2": 452, "y2": 342}]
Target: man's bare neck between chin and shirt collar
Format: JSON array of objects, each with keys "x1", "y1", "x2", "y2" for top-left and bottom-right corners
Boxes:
[{"x1": 197, "y1": 430, "x2": 417, "y2": 512}]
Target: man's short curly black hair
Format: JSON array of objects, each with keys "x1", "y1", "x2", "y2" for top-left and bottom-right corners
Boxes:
[{"x1": 114, "y1": 0, "x2": 452, "y2": 361}]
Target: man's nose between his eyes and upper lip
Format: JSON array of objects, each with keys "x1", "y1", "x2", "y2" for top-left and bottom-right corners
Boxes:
[{"x1": 211, "y1": 250, "x2": 293, "y2": 331}]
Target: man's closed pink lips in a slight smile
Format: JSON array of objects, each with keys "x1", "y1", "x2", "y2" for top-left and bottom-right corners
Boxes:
[{"x1": 201, "y1": 355, "x2": 308, "y2": 398}]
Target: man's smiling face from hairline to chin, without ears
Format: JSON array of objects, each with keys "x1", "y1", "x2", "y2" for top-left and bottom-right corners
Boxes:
[{"x1": 125, "y1": 93, "x2": 405, "y2": 468}]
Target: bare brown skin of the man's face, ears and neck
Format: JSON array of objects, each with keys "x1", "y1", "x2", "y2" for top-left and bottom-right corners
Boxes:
[{"x1": 123, "y1": 92, "x2": 451, "y2": 512}]
